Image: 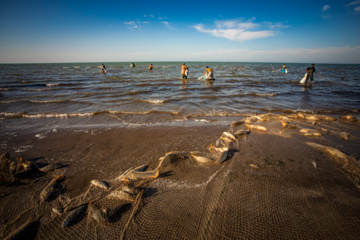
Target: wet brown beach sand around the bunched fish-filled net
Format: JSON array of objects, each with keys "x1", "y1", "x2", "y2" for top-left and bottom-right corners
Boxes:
[{"x1": 0, "y1": 115, "x2": 360, "y2": 239}]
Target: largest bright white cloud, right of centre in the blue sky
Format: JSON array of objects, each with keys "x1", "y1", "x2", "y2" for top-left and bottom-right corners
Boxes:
[{"x1": 193, "y1": 18, "x2": 288, "y2": 41}]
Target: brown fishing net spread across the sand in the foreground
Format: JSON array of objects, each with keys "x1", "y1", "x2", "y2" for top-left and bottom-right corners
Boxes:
[{"x1": 0, "y1": 113, "x2": 360, "y2": 239}]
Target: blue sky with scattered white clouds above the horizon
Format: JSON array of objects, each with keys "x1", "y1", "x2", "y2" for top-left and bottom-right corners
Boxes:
[{"x1": 0, "y1": 0, "x2": 360, "y2": 64}]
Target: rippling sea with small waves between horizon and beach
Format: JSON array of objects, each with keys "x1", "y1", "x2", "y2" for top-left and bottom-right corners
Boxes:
[{"x1": 0, "y1": 62, "x2": 360, "y2": 132}]
